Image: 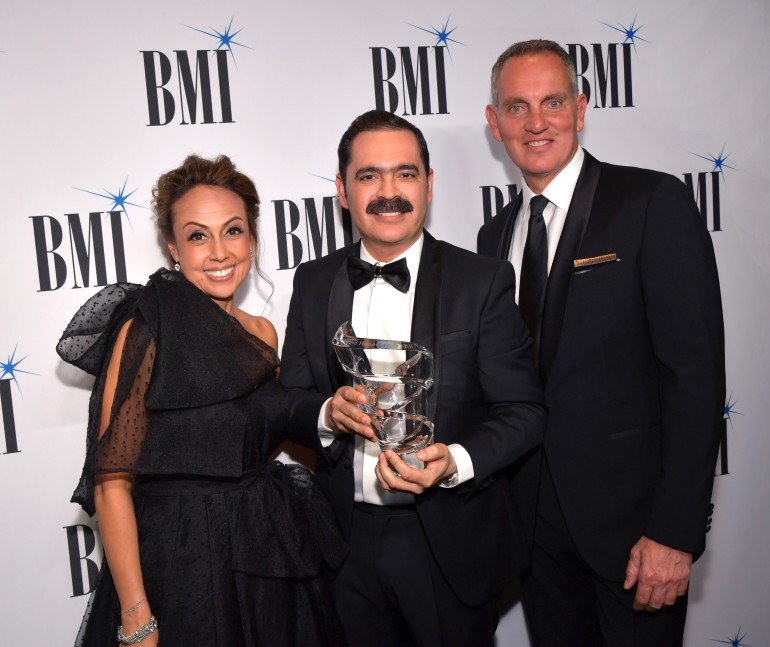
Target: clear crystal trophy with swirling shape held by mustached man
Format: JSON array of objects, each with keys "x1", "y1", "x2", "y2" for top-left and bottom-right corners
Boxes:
[{"x1": 332, "y1": 321, "x2": 433, "y2": 469}]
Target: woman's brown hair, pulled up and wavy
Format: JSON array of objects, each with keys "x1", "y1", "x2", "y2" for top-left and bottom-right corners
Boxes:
[{"x1": 152, "y1": 155, "x2": 259, "y2": 268}]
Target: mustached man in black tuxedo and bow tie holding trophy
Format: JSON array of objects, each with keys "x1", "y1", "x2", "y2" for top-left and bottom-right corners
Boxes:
[{"x1": 281, "y1": 111, "x2": 545, "y2": 647}]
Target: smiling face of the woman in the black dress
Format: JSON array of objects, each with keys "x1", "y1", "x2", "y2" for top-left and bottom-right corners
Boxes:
[{"x1": 168, "y1": 184, "x2": 252, "y2": 312}]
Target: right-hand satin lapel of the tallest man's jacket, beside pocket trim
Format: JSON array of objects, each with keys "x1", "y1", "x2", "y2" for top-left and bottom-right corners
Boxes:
[{"x1": 539, "y1": 152, "x2": 601, "y2": 384}]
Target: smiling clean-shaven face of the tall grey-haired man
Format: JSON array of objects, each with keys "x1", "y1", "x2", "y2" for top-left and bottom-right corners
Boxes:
[{"x1": 487, "y1": 52, "x2": 586, "y2": 194}]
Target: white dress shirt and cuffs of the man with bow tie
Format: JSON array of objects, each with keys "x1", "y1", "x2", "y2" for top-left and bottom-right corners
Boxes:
[{"x1": 318, "y1": 236, "x2": 473, "y2": 505}]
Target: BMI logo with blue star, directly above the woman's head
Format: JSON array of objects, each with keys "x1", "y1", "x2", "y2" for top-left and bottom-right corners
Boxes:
[{"x1": 141, "y1": 18, "x2": 246, "y2": 126}]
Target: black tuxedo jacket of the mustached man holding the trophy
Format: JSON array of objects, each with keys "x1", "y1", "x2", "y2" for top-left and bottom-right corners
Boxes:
[{"x1": 281, "y1": 232, "x2": 545, "y2": 606}]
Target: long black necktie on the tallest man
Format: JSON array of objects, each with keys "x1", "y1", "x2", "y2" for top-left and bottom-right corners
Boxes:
[{"x1": 519, "y1": 195, "x2": 548, "y2": 356}]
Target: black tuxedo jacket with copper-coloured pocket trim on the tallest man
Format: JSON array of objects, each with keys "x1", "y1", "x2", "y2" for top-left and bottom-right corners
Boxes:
[{"x1": 478, "y1": 153, "x2": 725, "y2": 580}]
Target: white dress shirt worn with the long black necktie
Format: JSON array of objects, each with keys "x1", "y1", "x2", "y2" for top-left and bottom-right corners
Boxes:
[{"x1": 508, "y1": 146, "x2": 585, "y2": 303}]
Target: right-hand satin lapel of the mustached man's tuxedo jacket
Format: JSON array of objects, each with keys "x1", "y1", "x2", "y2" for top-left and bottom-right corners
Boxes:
[{"x1": 411, "y1": 231, "x2": 443, "y2": 423}]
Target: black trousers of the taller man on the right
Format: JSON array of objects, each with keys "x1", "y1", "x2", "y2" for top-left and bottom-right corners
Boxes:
[{"x1": 523, "y1": 460, "x2": 687, "y2": 647}]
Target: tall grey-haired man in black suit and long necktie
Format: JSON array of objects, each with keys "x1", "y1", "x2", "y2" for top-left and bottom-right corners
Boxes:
[{"x1": 478, "y1": 40, "x2": 725, "y2": 647}]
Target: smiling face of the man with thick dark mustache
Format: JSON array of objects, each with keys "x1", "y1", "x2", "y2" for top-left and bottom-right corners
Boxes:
[{"x1": 337, "y1": 130, "x2": 433, "y2": 263}]
